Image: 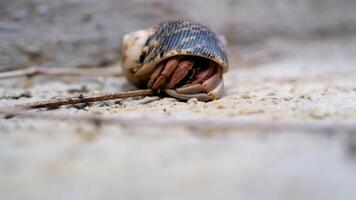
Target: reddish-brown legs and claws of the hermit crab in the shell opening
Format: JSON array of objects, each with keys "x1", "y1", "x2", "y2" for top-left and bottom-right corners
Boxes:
[{"x1": 147, "y1": 57, "x2": 224, "y2": 101}]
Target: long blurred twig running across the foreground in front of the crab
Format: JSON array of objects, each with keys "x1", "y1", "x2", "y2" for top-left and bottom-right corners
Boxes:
[{"x1": 0, "y1": 108, "x2": 356, "y2": 134}]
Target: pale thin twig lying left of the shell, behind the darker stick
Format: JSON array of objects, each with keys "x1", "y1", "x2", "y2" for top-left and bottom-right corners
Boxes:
[{"x1": 0, "y1": 66, "x2": 121, "y2": 79}]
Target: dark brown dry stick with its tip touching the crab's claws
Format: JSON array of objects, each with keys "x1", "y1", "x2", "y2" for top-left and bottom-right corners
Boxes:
[{"x1": 15, "y1": 89, "x2": 154, "y2": 109}]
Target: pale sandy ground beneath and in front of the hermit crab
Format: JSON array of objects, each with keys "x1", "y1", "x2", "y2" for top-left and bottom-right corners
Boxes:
[{"x1": 0, "y1": 35, "x2": 356, "y2": 200}]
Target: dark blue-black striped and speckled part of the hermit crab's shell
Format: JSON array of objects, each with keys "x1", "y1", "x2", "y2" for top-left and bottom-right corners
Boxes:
[{"x1": 135, "y1": 20, "x2": 228, "y2": 77}]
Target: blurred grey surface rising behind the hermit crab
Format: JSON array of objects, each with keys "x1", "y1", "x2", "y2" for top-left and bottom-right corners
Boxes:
[{"x1": 0, "y1": 0, "x2": 356, "y2": 70}]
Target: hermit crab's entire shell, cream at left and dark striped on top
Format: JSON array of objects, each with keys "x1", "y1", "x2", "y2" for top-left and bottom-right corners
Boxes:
[{"x1": 122, "y1": 20, "x2": 228, "y2": 87}]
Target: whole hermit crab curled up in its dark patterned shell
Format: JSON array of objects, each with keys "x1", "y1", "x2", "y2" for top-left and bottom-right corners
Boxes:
[{"x1": 122, "y1": 20, "x2": 228, "y2": 101}]
